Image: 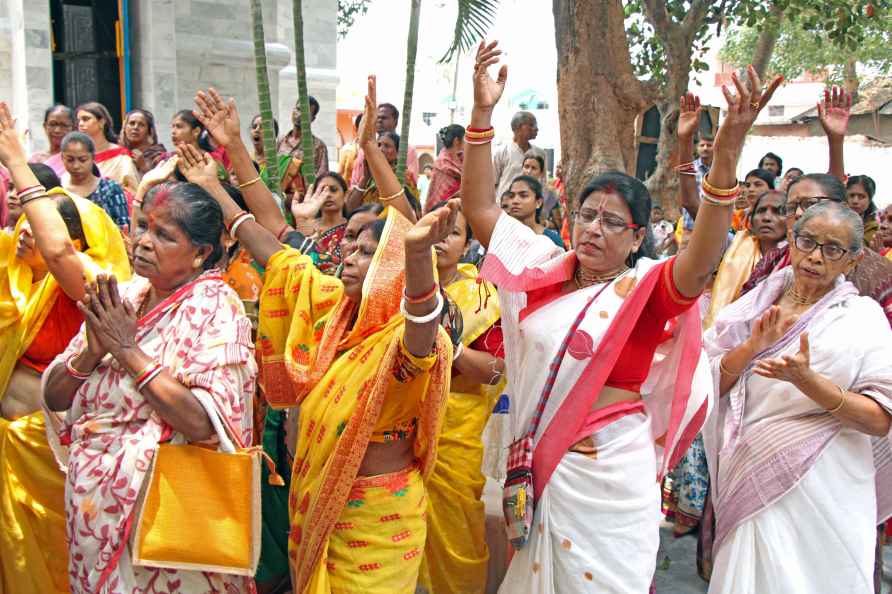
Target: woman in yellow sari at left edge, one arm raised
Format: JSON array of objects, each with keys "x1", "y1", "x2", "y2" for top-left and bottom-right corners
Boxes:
[{"x1": 0, "y1": 99, "x2": 130, "y2": 594}]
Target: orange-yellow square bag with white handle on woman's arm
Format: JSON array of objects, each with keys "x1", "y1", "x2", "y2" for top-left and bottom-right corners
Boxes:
[{"x1": 131, "y1": 392, "x2": 284, "y2": 576}]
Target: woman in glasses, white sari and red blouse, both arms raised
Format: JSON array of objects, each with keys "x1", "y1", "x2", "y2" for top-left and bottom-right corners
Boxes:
[{"x1": 461, "y1": 43, "x2": 779, "y2": 594}]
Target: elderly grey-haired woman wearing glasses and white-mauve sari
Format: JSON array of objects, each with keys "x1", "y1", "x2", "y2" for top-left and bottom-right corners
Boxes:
[{"x1": 704, "y1": 200, "x2": 892, "y2": 594}]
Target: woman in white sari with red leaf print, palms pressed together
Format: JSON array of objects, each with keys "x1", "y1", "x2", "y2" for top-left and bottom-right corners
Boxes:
[{"x1": 43, "y1": 183, "x2": 257, "y2": 594}]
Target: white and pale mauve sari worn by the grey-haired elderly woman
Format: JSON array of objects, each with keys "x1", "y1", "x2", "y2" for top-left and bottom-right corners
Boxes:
[{"x1": 703, "y1": 267, "x2": 892, "y2": 594}]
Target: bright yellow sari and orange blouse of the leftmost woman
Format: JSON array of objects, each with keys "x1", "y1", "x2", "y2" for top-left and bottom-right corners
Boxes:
[{"x1": 0, "y1": 190, "x2": 130, "y2": 594}]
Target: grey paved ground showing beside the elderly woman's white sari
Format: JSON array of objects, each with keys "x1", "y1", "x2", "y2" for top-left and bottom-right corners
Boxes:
[{"x1": 656, "y1": 528, "x2": 892, "y2": 594}]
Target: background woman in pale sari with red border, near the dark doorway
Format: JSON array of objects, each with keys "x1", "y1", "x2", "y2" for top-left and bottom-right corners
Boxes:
[{"x1": 76, "y1": 101, "x2": 140, "y2": 195}]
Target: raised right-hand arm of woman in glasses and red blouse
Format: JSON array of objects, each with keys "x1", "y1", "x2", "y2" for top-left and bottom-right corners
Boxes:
[{"x1": 672, "y1": 66, "x2": 782, "y2": 297}]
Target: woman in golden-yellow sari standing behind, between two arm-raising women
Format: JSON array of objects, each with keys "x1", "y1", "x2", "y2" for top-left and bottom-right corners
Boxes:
[{"x1": 419, "y1": 206, "x2": 505, "y2": 594}]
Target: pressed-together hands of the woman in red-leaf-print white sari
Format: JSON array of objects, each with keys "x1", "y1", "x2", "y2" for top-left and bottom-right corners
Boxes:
[{"x1": 77, "y1": 274, "x2": 137, "y2": 360}]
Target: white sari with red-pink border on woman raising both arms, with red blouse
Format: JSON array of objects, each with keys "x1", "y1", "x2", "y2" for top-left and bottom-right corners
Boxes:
[{"x1": 482, "y1": 214, "x2": 711, "y2": 594}]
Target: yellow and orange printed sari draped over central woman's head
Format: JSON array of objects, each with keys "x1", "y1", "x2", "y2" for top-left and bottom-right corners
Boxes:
[{"x1": 258, "y1": 209, "x2": 452, "y2": 593}]
